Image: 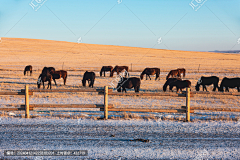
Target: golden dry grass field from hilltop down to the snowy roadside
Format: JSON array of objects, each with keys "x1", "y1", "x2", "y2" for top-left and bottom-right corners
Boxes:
[{"x1": 0, "y1": 38, "x2": 240, "y2": 119}]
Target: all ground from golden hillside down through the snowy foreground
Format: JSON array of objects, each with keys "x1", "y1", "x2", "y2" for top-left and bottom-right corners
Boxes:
[{"x1": 0, "y1": 38, "x2": 240, "y2": 159}]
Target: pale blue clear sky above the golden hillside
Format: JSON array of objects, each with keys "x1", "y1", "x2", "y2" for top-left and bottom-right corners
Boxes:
[{"x1": 0, "y1": 0, "x2": 240, "y2": 51}]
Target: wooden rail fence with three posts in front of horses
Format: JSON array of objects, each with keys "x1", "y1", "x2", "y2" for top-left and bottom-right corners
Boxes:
[{"x1": 0, "y1": 85, "x2": 240, "y2": 122}]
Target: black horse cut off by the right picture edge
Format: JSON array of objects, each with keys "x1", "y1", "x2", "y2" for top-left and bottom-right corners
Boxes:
[{"x1": 218, "y1": 77, "x2": 240, "y2": 92}]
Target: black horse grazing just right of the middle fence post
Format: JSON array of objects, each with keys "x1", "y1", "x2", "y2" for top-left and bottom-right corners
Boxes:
[{"x1": 117, "y1": 77, "x2": 141, "y2": 92}]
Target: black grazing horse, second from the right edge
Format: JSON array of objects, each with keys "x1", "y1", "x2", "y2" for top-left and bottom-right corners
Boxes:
[{"x1": 195, "y1": 76, "x2": 219, "y2": 91}]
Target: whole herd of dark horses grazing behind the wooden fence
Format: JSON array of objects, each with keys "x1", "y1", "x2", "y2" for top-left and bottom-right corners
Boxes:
[{"x1": 24, "y1": 65, "x2": 240, "y2": 92}]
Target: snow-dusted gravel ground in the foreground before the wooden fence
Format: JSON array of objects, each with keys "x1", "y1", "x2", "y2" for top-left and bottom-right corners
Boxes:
[{"x1": 0, "y1": 118, "x2": 240, "y2": 159}]
